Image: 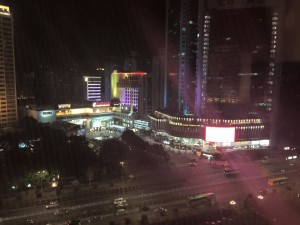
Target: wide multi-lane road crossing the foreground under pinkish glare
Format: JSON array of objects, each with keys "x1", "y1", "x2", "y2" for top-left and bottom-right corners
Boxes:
[{"x1": 1, "y1": 147, "x2": 300, "y2": 225}]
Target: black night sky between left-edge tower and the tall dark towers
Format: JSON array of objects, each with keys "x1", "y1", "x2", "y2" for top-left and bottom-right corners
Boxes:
[{"x1": 4, "y1": 0, "x2": 165, "y2": 71}]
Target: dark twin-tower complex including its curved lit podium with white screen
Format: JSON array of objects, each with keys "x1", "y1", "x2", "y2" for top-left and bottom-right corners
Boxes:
[{"x1": 149, "y1": 0, "x2": 285, "y2": 149}]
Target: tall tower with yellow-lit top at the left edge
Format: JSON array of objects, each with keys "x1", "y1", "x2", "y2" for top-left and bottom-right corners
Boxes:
[{"x1": 0, "y1": 5, "x2": 18, "y2": 127}]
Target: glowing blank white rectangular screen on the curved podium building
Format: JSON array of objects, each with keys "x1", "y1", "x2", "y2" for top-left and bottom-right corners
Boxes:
[{"x1": 205, "y1": 127, "x2": 235, "y2": 142}]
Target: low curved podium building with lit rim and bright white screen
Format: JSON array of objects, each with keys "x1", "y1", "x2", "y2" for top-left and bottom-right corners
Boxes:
[{"x1": 149, "y1": 111, "x2": 269, "y2": 150}]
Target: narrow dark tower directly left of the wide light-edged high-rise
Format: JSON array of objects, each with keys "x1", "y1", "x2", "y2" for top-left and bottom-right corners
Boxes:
[{"x1": 165, "y1": 0, "x2": 198, "y2": 114}]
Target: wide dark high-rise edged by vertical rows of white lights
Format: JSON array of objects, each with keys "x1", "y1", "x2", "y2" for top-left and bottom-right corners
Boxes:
[{"x1": 195, "y1": 0, "x2": 283, "y2": 121}]
